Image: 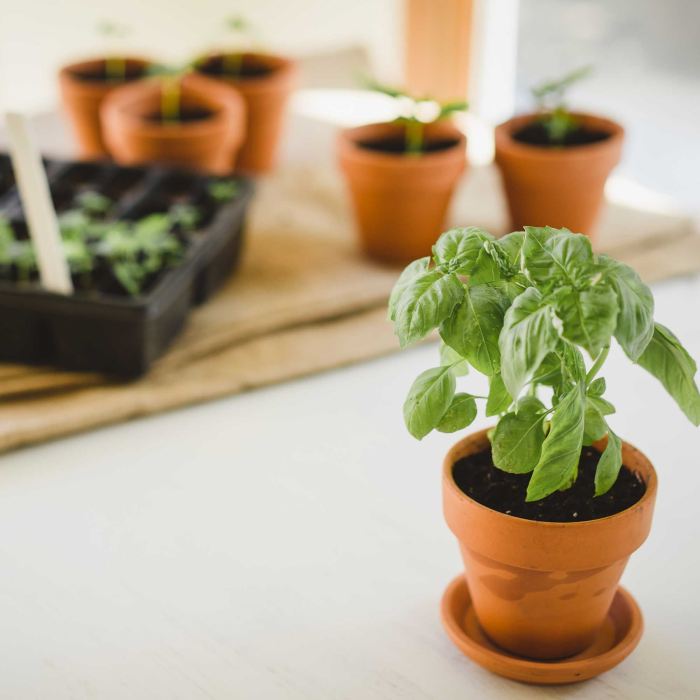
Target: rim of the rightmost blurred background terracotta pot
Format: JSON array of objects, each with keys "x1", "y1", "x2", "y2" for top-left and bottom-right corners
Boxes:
[{"x1": 494, "y1": 112, "x2": 625, "y2": 161}]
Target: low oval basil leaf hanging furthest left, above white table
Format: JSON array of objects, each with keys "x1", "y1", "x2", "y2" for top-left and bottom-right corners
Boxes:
[{"x1": 403, "y1": 367, "x2": 455, "y2": 440}]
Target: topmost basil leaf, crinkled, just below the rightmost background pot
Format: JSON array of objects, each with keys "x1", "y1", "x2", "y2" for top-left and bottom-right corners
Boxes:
[{"x1": 523, "y1": 226, "x2": 594, "y2": 289}]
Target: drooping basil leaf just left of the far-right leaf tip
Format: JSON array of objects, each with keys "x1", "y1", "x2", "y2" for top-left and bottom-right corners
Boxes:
[{"x1": 598, "y1": 255, "x2": 654, "y2": 360}]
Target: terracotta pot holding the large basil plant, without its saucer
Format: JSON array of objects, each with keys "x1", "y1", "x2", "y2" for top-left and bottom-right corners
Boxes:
[{"x1": 443, "y1": 430, "x2": 656, "y2": 659}]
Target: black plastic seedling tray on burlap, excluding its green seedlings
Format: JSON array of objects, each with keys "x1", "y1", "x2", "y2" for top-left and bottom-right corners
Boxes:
[{"x1": 0, "y1": 154, "x2": 253, "y2": 377}]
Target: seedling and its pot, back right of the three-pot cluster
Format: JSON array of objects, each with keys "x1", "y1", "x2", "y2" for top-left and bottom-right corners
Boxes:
[{"x1": 195, "y1": 16, "x2": 297, "y2": 174}]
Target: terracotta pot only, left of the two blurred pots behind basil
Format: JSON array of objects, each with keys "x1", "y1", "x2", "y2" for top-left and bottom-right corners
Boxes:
[{"x1": 338, "y1": 122, "x2": 467, "y2": 264}]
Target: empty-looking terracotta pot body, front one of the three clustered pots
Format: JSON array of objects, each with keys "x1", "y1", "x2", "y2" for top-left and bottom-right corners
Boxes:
[{"x1": 100, "y1": 75, "x2": 245, "y2": 174}]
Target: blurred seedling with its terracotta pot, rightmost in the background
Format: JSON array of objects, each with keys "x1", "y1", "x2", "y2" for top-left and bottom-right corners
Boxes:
[{"x1": 496, "y1": 68, "x2": 624, "y2": 241}]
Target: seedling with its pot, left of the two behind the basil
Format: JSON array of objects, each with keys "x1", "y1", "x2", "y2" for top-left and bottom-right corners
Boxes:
[{"x1": 338, "y1": 81, "x2": 467, "y2": 263}]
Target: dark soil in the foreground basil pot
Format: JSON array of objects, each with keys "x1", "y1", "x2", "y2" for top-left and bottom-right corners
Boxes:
[{"x1": 452, "y1": 447, "x2": 646, "y2": 522}]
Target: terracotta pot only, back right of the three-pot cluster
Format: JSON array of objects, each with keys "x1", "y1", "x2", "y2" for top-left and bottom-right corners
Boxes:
[{"x1": 198, "y1": 53, "x2": 297, "y2": 173}]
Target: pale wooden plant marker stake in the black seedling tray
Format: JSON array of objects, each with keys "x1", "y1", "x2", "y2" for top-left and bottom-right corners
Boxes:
[{"x1": 5, "y1": 112, "x2": 73, "y2": 294}]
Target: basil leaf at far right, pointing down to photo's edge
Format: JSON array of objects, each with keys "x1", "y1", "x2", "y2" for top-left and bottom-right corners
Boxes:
[{"x1": 637, "y1": 323, "x2": 700, "y2": 425}]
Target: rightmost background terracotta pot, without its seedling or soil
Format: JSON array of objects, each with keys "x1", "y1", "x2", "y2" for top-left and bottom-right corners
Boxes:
[{"x1": 496, "y1": 114, "x2": 624, "y2": 242}]
